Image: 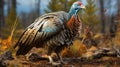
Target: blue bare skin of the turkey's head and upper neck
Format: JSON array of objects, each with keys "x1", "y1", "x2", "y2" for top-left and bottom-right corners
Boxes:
[{"x1": 68, "y1": 4, "x2": 81, "y2": 19}]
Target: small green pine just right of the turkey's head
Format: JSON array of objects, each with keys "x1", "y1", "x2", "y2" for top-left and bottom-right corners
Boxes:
[{"x1": 80, "y1": 0, "x2": 99, "y2": 30}]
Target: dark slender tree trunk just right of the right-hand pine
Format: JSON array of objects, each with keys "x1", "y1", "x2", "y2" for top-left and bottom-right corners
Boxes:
[{"x1": 99, "y1": 0, "x2": 105, "y2": 33}]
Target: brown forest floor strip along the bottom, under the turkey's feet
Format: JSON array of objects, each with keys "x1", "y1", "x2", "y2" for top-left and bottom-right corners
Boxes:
[{"x1": 0, "y1": 47, "x2": 120, "y2": 67}]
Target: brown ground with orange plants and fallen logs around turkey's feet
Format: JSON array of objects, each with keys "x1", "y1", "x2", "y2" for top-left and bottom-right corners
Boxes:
[{"x1": 0, "y1": 27, "x2": 120, "y2": 67}]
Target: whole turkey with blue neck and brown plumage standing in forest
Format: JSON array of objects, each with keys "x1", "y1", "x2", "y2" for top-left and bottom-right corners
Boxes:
[{"x1": 14, "y1": 1, "x2": 85, "y2": 64}]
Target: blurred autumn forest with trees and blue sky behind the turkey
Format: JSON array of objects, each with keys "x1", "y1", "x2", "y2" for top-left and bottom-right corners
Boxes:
[{"x1": 0, "y1": 0, "x2": 120, "y2": 56}]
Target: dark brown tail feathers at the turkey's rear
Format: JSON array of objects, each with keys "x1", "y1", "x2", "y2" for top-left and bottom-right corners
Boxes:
[{"x1": 14, "y1": 28, "x2": 37, "y2": 55}]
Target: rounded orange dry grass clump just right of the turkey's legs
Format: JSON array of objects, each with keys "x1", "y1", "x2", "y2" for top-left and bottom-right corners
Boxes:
[{"x1": 62, "y1": 40, "x2": 87, "y2": 57}]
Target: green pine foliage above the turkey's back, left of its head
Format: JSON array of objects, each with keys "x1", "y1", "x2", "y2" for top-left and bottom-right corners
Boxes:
[{"x1": 45, "y1": 0, "x2": 77, "y2": 13}]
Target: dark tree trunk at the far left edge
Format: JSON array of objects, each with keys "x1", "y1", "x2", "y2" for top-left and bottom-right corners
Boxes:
[{"x1": 0, "y1": 0, "x2": 5, "y2": 31}]
